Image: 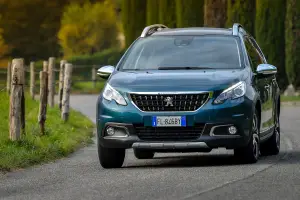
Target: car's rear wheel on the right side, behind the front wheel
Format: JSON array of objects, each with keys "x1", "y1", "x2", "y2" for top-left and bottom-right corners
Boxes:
[{"x1": 260, "y1": 110, "x2": 280, "y2": 156}]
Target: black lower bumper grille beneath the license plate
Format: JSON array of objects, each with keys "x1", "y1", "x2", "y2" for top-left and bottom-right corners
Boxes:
[{"x1": 135, "y1": 124, "x2": 204, "y2": 141}]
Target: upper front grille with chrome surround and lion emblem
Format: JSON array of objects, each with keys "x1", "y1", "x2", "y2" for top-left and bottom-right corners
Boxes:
[{"x1": 130, "y1": 93, "x2": 209, "y2": 112}]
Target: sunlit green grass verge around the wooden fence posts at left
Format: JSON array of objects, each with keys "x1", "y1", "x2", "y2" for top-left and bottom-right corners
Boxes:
[{"x1": 0, "y1": 92, "x2": 94, "y2": 171}]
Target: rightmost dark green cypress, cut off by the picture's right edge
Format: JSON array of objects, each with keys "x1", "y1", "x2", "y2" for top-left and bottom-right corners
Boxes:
[{"x1": 285, "y1": 0, "x2": 300, "y2": 88}]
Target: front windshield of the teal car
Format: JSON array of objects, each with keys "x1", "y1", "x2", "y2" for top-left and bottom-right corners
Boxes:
[{"x1": 119, "y1": 36, "x2": 241, "y2": 70}]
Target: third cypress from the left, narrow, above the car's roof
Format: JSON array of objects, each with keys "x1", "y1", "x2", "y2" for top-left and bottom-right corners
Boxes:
[{"x1": 159, "y1": 0, "x2": 176, "y2": 28}]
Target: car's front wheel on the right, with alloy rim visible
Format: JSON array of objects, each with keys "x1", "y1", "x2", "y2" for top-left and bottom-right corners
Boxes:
[{"x1": 234, "y1": 111, "x2": 260, "y2": 163}]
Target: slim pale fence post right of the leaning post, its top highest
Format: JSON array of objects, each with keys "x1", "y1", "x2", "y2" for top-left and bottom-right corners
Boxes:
[{"x1": 48, "y1": 57, "x2": 55, "y2": 107}]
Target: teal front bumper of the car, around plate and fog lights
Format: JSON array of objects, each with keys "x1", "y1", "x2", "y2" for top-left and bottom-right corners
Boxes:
[{"x1": 97, "y1": 97, "x2": 253, "y2": 152}]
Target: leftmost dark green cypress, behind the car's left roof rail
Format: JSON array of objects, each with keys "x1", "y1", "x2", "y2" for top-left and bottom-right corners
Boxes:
[{"x1": 122, "y1": 0, "x2": 147, "y2": 47}]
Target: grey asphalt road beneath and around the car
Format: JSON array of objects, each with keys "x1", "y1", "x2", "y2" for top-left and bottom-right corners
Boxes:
[{"x1": 0, "y1": 96, "x2": 300, "y2": 200}]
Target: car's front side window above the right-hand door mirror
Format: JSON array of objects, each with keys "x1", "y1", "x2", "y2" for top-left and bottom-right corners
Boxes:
[{"x1": 244, "y1": 37, "x2": 264, "y2": 72}]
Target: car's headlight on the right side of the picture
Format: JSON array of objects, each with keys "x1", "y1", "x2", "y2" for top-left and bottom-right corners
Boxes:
[{"x1": 214, "y1": 81, "x2": 246, "y2": 104}]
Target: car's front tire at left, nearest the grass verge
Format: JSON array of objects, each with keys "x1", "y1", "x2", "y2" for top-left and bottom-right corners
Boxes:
[{"x1": 98, "y1": 144, "x2": 125, "y2": 169}]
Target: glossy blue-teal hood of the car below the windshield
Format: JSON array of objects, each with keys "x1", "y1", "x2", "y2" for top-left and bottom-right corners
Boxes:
[{"x1": 108, "y1": 69, "x2": 249, "y2": 92}]
